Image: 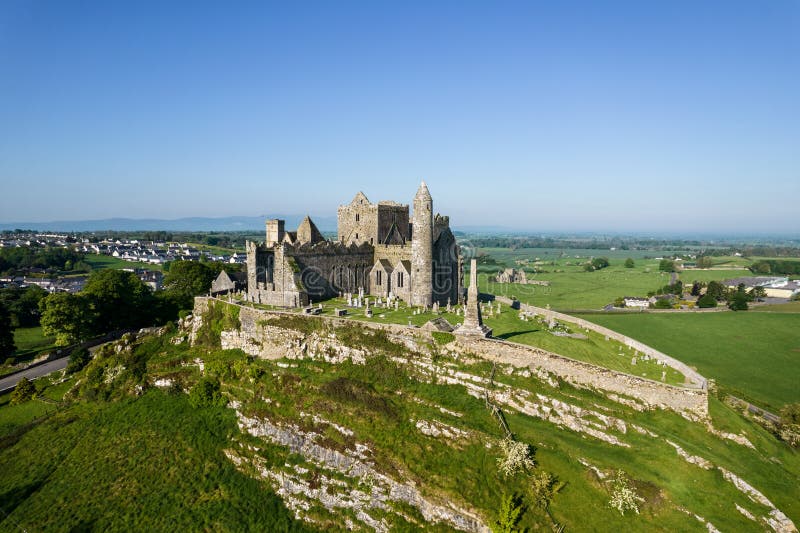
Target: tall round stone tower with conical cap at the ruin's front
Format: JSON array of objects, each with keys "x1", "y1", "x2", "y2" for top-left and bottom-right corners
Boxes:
[{"x1": 411, "y1": 181, "x2": 433, "y2": 306}]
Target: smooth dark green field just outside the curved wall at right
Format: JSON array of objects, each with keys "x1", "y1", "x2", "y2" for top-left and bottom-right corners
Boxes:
[{"x1": 582, "y1": 311, "x2": 800, "y2": 410}]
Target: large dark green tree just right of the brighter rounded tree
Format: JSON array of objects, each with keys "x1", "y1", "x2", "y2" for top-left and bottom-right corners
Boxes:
[{"x1": 81, "y1": 269, "x2": 155, "y2": 333}]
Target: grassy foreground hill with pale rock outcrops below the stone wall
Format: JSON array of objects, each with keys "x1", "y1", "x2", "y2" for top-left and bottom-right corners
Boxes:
[{"x1": 0, "y1": 319, "x2": 800, "y2": 531}]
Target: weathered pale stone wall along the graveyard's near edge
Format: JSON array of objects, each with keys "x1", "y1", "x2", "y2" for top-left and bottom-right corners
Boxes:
[{"x1": 193, "y1": 296, "x2": 708, "y2": 418}]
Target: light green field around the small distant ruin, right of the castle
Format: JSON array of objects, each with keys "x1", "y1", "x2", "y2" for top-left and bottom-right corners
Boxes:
[{"x1": 478, "y1": 248, "x2": 748, "y2": 311}]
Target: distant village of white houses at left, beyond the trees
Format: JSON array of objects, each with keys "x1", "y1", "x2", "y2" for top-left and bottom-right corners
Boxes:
[{"x1": 0, "y1": 233, "x2": 246, "y2": 293}]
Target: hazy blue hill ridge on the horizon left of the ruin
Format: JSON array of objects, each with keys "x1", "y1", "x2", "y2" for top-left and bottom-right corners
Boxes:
[{"x1": 0, "y1": 214, "x2": 336, "y2": 231}]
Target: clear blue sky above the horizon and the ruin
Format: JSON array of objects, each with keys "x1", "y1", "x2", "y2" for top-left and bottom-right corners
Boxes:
[{"x1": 0, "y1": 0, "x2": 800, "y2": 234}]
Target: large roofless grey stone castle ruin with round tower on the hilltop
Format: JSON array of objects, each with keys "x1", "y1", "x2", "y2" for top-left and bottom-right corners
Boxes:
[{"x1": 247, "y1": 182, "x2": 463, "y2": 307}]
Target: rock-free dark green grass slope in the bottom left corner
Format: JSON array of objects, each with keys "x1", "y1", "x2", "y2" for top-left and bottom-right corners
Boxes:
[{"x1": 0, "y1": 391, "x2": 305, "y2": 531}]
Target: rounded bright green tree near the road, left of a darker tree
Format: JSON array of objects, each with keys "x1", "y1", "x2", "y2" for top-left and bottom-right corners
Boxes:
[{"x1": 39, "y1": 292, "x2": 94, "y2": 346}]
